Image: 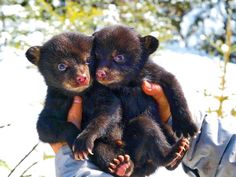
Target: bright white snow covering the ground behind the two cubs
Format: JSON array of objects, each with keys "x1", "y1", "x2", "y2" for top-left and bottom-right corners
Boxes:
[{"x1": 0, "y1": 48, "x2": 236, "y2": 177}]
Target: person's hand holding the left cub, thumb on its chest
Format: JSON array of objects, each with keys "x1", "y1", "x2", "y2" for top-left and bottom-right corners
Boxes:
[{"x1": 50, "y1": 96, "x2": 82, "y2": 153}]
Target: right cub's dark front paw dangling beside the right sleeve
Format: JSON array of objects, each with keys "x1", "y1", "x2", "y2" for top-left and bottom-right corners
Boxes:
[{"x1": 172, "y1": 117, "x2": 198, "y2": 138}]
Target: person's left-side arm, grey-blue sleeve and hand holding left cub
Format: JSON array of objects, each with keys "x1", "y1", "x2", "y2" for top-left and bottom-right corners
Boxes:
[{"x1": 50, "y1": 96, "x2": 112, "y2": 177}]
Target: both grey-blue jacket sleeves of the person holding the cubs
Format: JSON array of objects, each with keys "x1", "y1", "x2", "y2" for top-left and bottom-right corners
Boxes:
[{"x1": 55, "y1": 114, "x2": 236, "y2": 177}]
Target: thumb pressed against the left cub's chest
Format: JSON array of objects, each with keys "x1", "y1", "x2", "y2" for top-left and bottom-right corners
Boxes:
[{"x1": 67, "y1": 96, "x2": 82, "y2": 129}]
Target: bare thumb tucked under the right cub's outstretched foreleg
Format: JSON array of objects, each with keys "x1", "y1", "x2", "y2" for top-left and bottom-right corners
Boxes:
[{"x1": 142, "y1": 80, "x2": 171, "y2": 123}]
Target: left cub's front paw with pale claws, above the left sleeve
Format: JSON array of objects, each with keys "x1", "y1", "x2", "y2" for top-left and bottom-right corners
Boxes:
[{"x1": 72, "y1": 132, "x2": 95, "y2": 160}]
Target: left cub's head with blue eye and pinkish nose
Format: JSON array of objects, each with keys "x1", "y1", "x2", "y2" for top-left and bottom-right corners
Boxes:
[{"x1": 26, "y1": 33, "x2": 94, "y2": 94}]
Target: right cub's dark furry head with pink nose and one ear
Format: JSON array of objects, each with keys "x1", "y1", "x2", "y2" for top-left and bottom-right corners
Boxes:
[{"x1": 94, "y1": 26, "x2": 159, "y2": 88}]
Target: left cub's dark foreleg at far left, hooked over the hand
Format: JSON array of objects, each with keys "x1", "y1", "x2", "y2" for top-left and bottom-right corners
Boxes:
[{"x1": 37, "y1": 87, "x2": 80, "y2": 147}]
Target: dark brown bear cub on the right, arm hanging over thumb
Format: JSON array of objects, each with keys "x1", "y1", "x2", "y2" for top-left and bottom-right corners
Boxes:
[{"x1": 94, "y1": 26, "x2": 197, "y2": 177}]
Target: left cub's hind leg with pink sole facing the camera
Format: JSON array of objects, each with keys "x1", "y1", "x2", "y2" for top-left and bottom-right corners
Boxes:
[{"x1": 92, "y1": 125, "x2": 134, "y2": 177}]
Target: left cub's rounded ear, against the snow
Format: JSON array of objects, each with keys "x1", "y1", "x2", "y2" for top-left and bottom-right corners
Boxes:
[{"x1": 25, "y1": 46, "x2": 41, "y2": 65}]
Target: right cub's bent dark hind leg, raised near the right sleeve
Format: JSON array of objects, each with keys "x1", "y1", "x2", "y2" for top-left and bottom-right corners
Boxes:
[{"x1": 124, "y1": 114, "x2": 187, "y2": 177}]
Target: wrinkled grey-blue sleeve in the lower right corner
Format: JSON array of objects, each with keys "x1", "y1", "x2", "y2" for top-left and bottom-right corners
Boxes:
[{"x1": 183, "y1": 116, "x2": 236, "y2": 177}]
